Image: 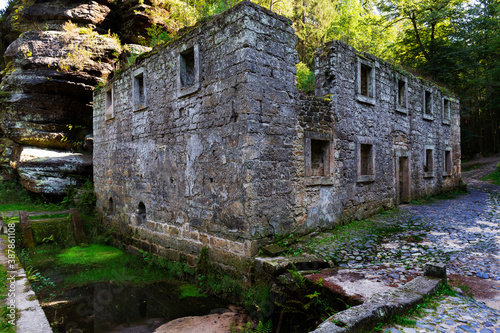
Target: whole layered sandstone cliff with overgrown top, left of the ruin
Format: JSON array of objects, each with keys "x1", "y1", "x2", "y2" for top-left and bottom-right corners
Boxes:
[{"x1": 0, "y1": 0, "x2": 182, "y2": 194}]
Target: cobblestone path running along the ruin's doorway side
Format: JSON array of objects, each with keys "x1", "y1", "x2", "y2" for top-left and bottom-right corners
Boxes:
[{"x1": 308, "y1": 157, "x2": 500, "y2": 333}]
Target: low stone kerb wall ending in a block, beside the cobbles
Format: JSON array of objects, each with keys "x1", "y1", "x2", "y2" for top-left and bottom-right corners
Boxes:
[{"x1": 310, "y1": 263, "x2": 446, "y2": 333}]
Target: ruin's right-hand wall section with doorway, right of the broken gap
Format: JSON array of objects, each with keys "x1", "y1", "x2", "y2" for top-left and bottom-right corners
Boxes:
[{"x1": 308, "y1": 41, "x2": 460, "y2": 225}]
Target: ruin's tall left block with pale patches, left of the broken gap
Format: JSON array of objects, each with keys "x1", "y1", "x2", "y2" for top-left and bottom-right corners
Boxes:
[{"x1": 94, "y1": 2, "x2": 297, "y2": 263}]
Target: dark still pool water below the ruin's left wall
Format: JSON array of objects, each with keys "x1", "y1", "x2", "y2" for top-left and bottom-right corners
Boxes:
[{"x1": 43, "y1": 282, "x2": 227, "y2": 333}]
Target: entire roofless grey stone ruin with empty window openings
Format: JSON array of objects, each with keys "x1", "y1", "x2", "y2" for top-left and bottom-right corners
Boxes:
[{"x1": 93, "y1": 2, "x2": 460, "y2": 267}]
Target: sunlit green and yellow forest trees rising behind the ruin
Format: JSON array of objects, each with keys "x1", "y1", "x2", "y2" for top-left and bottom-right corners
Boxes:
[{"x1": 0, "y1": 0, "x2": 500, "y2": 156}]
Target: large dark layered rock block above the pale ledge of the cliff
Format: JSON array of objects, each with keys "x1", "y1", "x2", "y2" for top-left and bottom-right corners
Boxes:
[{"x1": 0, "y1": 31, "x2": 121, "y2": 149}]
